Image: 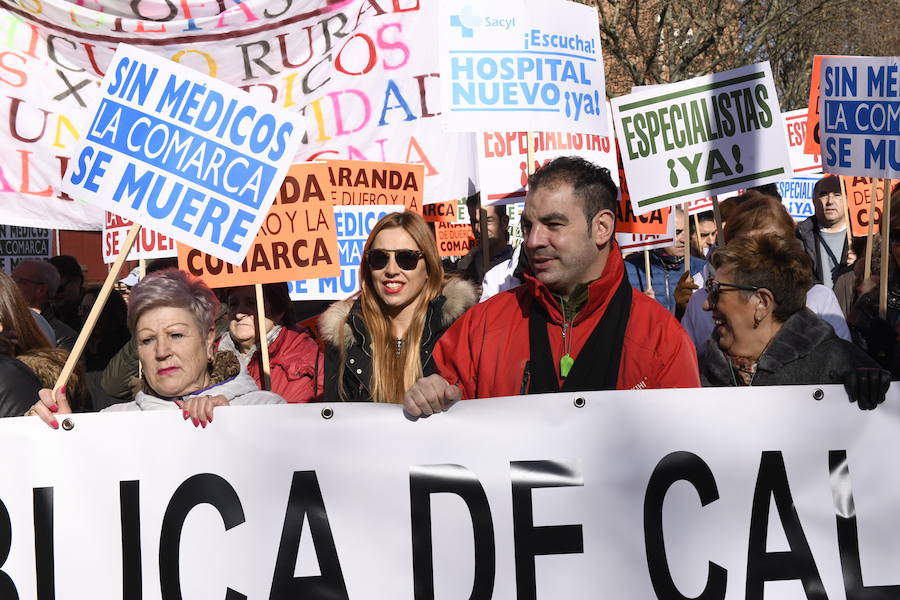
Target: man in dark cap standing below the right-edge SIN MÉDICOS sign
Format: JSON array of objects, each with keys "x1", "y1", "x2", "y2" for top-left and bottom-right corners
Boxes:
[{"x1": 797, "y1": 175, "x2": 849, "y2": 288}]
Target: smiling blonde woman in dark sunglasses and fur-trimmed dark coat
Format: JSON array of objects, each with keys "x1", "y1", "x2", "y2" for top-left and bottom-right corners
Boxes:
[{"x1": 319, "y1": 211, "x2": 476, "y2": 403}]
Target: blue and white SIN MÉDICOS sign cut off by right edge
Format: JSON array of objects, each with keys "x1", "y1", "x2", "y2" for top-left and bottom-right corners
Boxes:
[{"x1": 819, "y1": 56, "x2": 900, "y2": 179}]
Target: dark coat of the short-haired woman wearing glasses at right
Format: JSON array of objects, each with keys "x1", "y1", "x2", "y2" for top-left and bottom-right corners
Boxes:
[{"x1": 700, "y1": 308, "x2": 878, "y2": 387}]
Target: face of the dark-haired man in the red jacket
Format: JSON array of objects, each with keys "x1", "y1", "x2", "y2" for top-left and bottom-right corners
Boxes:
[{"x1": 522, "y1": 183, "x2": 612, "y2": 295}]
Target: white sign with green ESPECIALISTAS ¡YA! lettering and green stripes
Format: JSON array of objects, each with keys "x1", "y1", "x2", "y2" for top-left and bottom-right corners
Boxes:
[{"x1": 612, "y1": 62, "x2": 792, "y2": 214}]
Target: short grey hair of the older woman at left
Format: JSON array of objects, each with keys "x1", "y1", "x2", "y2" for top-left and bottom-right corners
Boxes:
[{"x1": 128, "y1": 269, "x2": 219, "y2": 336}]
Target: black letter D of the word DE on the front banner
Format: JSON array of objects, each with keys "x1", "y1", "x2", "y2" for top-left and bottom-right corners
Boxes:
[{"x1": 409, "y1": 465, "x2": 497, "y2": 600}]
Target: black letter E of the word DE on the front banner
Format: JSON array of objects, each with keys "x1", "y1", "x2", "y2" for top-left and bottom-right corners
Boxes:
[{"x1": 509, "y1": 460, "x2": 584, "y2": 600}]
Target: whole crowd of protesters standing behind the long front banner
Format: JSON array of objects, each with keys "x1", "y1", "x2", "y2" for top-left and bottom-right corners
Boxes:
[{"x1": 0, "y1": 157, "x2": 900, "y2": 428}]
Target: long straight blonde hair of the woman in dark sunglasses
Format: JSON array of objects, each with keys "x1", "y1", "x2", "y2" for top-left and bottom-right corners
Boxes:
[{"x1": 338, "y1": 211, "x2": 444, "y2": 404}]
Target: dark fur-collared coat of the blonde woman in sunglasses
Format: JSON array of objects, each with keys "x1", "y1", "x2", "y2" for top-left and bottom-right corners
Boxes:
[{"x1": 319, "y1": 279, "x2": 477, "y2": 402}]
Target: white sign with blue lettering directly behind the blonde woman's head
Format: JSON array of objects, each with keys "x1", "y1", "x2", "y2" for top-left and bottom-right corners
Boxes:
[{"x1": 288, "y1": 204, "x2": 403, "y2": 300}]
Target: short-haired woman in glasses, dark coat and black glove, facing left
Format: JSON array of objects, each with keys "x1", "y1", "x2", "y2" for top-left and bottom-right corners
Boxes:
[{"x1": 700, "y1": 234, "x2": 890, "y2": 409}]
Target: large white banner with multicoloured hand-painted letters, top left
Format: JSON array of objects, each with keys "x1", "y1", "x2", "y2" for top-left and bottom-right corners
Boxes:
[{"x1": 0, "y1": 0, "x2": 475, "y2": 230}]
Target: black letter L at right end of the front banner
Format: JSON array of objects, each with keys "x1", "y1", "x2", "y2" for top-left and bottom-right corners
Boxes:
[{"x1": 828, "y1": 450, "x2": 900, "y2": 600}]
